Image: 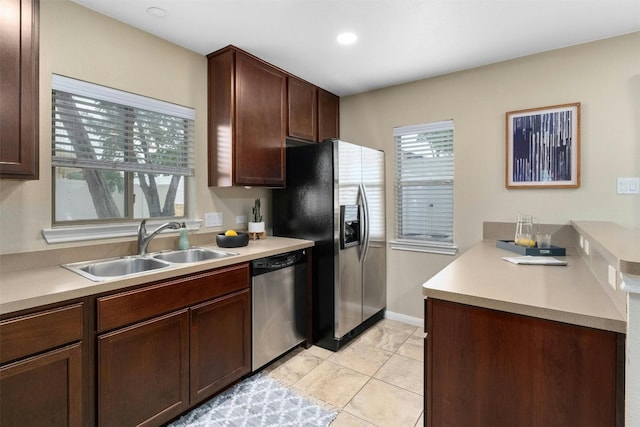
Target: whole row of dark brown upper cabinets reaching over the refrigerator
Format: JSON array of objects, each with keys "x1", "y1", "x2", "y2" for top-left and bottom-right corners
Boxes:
[{"x1": 207, "y1": 46, "x2": 340, "y2": 188}]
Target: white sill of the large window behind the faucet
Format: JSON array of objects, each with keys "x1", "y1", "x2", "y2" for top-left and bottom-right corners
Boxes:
[{"x1": 42, "y1": 219, "x2": 202, "y2": 244}]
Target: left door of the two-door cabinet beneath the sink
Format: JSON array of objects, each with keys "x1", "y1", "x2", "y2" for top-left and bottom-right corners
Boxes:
[{"x1": 98, "y1": 309, "x2": 189, "y2": 426}]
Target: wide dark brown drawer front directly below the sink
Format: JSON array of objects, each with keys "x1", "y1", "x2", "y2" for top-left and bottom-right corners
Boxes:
[{"x1": 98, "y1": 263, "x2": 250, "y2": 332}]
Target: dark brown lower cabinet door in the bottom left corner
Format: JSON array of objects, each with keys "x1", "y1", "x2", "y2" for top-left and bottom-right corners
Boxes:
[{"x1": 0, "y1": 344, "x2": 82, "y2": 427}]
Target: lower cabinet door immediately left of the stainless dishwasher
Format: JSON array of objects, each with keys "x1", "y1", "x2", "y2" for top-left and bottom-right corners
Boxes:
[{"x1": 190, "y1": 289, "x2": 251, "y2": 404}]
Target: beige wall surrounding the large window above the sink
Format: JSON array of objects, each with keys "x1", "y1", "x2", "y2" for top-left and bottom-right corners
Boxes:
[{"x1": 0, "y1": 0, "x2": 268, "y2": 254}]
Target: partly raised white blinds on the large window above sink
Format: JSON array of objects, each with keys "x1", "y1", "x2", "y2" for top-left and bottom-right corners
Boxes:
[{"x1": 52, "y1": 75, "x2": 195, "y2": 176}]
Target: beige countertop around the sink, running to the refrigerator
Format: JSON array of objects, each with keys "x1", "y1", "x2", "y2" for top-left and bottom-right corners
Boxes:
[{"x1": 0, "y1": 236, "x2": 314, "y2": 314}]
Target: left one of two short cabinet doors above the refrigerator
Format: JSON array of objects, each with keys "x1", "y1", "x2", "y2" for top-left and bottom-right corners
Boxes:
[{"x1": 287, "y1": 77, "x2": 318, "y2": 142}]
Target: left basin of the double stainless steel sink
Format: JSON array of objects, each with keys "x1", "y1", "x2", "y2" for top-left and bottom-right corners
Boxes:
[{"x1": 63, "y1": 256, "x2": 171, "y2": 281}]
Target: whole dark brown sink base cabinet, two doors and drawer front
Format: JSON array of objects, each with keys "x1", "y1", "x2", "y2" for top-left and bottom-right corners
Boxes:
[{"x1": 97, "y1": 263, "x2": 251, "y2": 427}]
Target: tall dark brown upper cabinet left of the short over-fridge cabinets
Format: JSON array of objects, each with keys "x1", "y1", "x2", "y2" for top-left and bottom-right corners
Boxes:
[{"x1": 207, "y1": 46, "x2": 287, "y2": 187}]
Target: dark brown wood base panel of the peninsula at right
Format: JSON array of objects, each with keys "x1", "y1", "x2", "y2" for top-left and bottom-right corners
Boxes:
[{"x1": 425, "y1": 298, "x2": 624, "y2": 427}]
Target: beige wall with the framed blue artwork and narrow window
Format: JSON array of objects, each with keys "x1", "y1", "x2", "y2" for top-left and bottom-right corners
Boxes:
[{"x1": 340, "y1": 33, "x2": 640, "y2": 318}]
